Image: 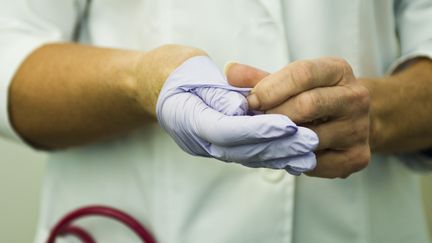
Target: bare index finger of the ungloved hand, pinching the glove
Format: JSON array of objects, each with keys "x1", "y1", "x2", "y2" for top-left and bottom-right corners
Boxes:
[{"x1": 248, "y1": 58, "x2": 353, "y2": 110}]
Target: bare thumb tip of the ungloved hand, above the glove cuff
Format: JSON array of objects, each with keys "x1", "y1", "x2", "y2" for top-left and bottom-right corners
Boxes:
[{"x1": 224, "y1": 62, "x2": 269, "y2": 88}]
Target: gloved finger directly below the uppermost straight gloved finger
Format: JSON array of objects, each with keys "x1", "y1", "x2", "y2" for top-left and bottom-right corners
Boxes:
[{"x1": 208, "y1": 127, "x2": 318, "y2": 162}]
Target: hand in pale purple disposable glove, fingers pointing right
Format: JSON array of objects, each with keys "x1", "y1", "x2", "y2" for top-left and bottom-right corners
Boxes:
[{"x1": 156, "y1": 56, "x2": 318, "y2": 175}]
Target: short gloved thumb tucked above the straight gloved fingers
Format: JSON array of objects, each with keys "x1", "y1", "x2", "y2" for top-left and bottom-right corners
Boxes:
[{"x1": 194, "y1": 87, "x2": 248, "y2": 116}]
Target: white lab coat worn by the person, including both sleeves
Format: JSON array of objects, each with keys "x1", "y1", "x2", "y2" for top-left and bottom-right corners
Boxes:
[{"x1": 0, "y1": 0, "x2": 432, "y2": 243}]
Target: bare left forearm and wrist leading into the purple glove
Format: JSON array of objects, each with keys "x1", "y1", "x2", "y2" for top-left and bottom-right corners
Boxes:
[{"x1": 9, "y1": 43, "x2": 206, "y2": 150}]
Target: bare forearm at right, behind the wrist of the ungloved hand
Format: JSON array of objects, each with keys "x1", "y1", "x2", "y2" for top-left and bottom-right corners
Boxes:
[{"x1": 363, "y1": 59, "x2": 432, "y2": 153}]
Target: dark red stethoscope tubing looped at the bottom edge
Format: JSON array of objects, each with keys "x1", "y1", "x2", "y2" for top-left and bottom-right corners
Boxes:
[{"x1": 47, "y1": 205, "x2": 156, "y2": 243}]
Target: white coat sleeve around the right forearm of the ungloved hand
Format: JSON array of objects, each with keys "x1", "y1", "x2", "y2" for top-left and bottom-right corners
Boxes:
[{"x1": 388, "y1": 0, "x2": 432, "y2": 171}]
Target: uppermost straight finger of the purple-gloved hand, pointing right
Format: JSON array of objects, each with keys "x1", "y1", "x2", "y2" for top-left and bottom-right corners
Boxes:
[{"x1": 162, "y1": 90, "x2": 297, "y2": 146}]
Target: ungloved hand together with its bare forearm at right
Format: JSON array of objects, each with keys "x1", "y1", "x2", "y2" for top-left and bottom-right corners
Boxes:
[{"x1": 226, "y1": 58, "x2": 432, "y2": 178}]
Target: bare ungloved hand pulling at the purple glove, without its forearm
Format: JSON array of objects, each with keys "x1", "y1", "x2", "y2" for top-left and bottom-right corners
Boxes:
[{"x1": 227, "y1": 58, "x2": 370, "y2": 178}]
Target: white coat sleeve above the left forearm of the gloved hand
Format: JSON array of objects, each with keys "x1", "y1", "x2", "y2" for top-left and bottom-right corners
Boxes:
[{"x1": 0, "y1": 0, "x2": 83, "y2": 141}]
